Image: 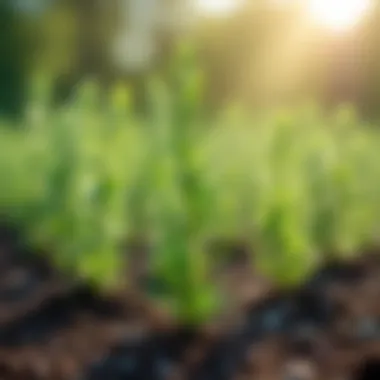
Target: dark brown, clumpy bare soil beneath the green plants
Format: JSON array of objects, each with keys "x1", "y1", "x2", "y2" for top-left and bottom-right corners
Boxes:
[{"x1": 0, "y1": 228, "x2": 380, "y2": 380}]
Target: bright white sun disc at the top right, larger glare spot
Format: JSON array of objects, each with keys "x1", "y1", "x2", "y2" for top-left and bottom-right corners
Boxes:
[{"x1": 308, "y1": 0, "x2": 371, "y2": 31}]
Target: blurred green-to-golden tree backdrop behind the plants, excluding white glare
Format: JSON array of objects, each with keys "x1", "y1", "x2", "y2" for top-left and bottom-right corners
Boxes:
[{"x1": 0, "y1": 0, "x2": 380, "y2": 119}]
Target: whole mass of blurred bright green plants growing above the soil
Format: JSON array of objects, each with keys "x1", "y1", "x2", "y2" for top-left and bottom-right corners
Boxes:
[{"x1": 0, "y1": 65, "x2": 380, "y2": 323}]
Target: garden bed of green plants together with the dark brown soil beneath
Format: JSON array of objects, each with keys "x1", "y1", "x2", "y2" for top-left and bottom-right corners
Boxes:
[{"x1": 0, "y1": 75, "x2": 380, "y2": 380}]
